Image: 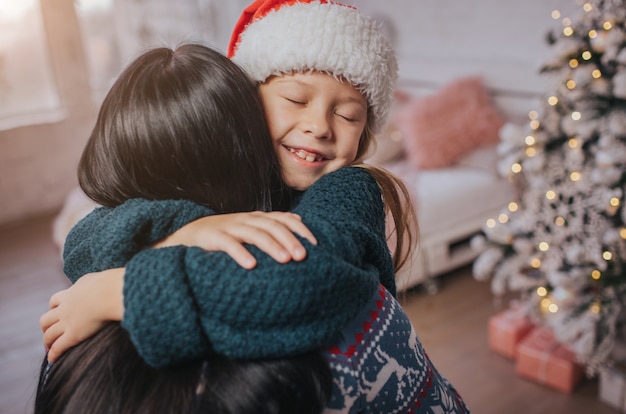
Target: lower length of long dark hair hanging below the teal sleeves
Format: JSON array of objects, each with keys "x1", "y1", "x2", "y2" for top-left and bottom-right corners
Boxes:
[{"x1": 35, "y1": 322, "x2": 332, "y2": 414}]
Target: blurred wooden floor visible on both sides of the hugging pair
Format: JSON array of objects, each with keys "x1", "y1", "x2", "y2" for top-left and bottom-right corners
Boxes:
[{"x1": 0, "y1": 217, "x2": 617, "y2": 414}]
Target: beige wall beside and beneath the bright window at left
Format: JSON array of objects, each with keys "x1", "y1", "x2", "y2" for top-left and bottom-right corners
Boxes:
[{"x1": 0, "y1": 0, "x2": 94, "y2": 223}]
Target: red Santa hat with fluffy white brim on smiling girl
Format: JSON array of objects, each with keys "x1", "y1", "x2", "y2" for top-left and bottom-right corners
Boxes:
[{"x1": 228, "y1": 0, "x2": 398, "y2": 132}]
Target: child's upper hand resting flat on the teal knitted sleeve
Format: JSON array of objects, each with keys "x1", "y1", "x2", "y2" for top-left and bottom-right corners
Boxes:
[{"x1": 153, "y1": 211, "x2": 317, "y2": 269}]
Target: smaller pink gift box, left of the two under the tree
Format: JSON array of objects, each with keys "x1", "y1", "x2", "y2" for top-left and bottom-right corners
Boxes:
[{"x1": 489, "y1": 308, "x2": 535, "y2": 359}]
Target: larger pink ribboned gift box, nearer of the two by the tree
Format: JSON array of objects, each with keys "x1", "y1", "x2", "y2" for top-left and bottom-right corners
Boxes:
[{"x1": 515, "y1": 327, "x2": 583, "y2": 393}]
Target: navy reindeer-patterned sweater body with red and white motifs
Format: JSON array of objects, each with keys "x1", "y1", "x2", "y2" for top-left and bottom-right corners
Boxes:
[{"x1": 323, "y1": 286, "x2": 469, "y2": 414}]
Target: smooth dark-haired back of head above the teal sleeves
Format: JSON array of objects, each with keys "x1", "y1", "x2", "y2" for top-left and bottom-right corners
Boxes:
[{"x1": 78, "y1": 44, "x2": 280, "y2": 212}]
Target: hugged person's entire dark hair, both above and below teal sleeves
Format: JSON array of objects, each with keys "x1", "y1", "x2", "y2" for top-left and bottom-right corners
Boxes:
[{"x1": 35, "y1": 44, "x2": 332, "y2": 414}]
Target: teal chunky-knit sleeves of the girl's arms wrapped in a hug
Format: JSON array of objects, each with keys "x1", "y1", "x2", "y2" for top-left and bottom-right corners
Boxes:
[{"x1": 64, "y1": 167, "x2": 395, "y2": 367}]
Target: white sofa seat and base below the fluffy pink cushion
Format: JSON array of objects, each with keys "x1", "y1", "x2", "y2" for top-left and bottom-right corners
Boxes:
[{"x1": 381, "y1": 145, "x2": 513, "y2": 293}]
